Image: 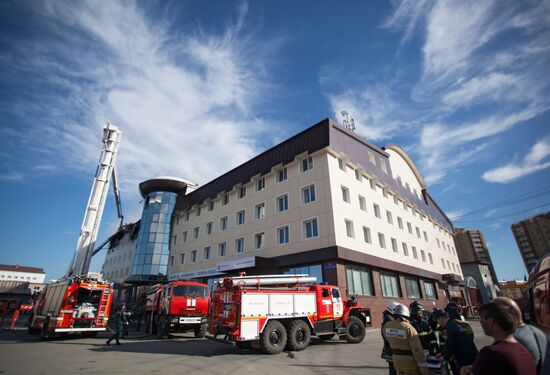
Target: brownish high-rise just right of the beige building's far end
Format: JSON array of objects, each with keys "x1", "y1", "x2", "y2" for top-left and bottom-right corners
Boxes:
[{"x1": 454, "y1": 228, "x2": 499, "y2": 303}]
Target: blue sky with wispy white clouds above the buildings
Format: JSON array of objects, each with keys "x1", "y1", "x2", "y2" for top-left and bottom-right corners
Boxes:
[{"x1": 0, "y1": 0, "x2": 550, "y2": 280}]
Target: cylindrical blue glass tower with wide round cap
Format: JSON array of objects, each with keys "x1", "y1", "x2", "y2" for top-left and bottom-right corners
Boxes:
[{"x1": 126, "y1": 177, "x2": 193, "y2": 283}]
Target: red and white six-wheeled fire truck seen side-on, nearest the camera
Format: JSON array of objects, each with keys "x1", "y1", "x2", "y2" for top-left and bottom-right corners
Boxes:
[{"x1": 209, "y1": 275, "x2": 371, "y2": 354}]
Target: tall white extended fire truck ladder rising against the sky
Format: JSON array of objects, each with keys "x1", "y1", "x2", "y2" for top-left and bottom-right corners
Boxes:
[{"x1": 65, "y1": 124, "x2": 122, "y2": 277}]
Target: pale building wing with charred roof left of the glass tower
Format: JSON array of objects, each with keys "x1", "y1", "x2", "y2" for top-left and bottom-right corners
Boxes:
[{"x1": 101, "y1": 221, "x2": 140, "y2": 283}]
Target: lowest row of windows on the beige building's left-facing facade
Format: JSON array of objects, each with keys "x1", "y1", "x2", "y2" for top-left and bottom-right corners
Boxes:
[{"x1": 170, "y1": 218, "x2": 319, "y2": 266}]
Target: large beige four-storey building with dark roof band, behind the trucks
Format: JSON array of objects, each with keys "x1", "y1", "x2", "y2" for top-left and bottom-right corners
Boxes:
[{"x1": 168, "y1": 119, "x2": 463, "y2": 325}]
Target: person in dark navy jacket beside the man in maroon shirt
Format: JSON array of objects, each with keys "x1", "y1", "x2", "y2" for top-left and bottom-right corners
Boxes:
[{"x1": 434, "y1": 309, "x2": 477, "y2": 375}]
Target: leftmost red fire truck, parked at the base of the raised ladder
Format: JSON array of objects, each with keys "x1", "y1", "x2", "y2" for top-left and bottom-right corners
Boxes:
[{"x1": 28, "y1": 273, "x2": 112, "y2": 340}]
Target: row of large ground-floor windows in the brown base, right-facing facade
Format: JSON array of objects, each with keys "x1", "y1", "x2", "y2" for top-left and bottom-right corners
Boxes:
[{"x1": 346, "y1": 264, "x2": 438, "y2": 300}]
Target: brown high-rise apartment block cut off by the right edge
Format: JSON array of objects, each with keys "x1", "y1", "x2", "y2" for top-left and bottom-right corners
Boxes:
[{"x1": 512, "y1": 212, "x2": 550, "y2": 272}]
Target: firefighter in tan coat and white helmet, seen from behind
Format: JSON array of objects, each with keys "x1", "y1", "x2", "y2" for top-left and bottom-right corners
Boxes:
[{"x1": 382, "y1": 304, "x2": 429, "y2": 375}]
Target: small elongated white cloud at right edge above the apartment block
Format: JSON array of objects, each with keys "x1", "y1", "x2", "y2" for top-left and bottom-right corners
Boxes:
[{"x1": 481, "y1": 138, "x2": 550, "y2": 184}]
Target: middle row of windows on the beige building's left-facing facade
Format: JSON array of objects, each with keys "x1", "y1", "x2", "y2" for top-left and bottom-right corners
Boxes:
[{"x1": 172, "y1": 185, "x2": 317, "y2": 245}]
